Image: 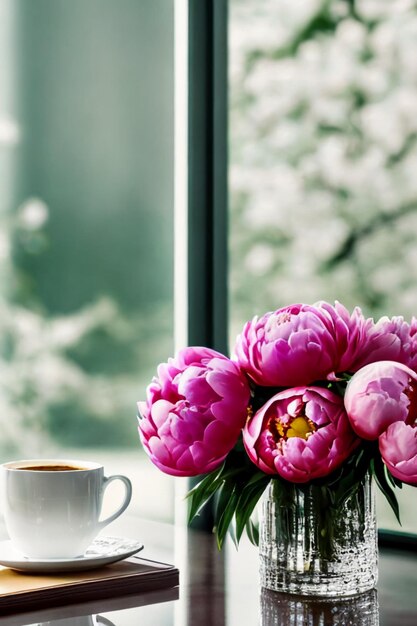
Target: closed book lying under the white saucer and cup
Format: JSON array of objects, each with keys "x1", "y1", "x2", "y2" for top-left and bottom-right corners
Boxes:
[{"x1": 0, "y1": 556, "x2": 179, "y2": 625}]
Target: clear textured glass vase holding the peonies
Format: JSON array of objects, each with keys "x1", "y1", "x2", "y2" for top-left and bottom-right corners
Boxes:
[{"x1": 259, "y1": 476, "x2": 378, "y2": 597}]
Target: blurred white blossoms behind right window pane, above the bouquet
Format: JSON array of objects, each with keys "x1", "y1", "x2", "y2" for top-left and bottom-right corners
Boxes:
[{"x1": 230, "y1": 0, "x2": 417, "y2": 344}]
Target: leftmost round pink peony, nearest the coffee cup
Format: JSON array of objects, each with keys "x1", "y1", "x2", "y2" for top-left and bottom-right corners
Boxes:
[{"x1": 138, "y1": 347, "x2": 250, "y2": 476}]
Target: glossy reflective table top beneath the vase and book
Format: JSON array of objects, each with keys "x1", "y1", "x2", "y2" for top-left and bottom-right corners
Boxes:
[{"x1": 0, "y1": 515, "x2": 417, "y2": 626}]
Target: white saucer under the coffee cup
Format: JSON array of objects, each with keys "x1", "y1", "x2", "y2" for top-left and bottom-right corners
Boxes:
[{"x1": 0, "y1": 537, "x2": 143, "y2": 572}]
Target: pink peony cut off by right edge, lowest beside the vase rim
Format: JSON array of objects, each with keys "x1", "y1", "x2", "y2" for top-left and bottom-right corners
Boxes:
[{"x1": 379, "y1": 422, "x2": 417, "y2": 486}]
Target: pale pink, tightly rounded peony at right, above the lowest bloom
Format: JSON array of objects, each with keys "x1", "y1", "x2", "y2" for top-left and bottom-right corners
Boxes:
[{"x1": 344, "y1": 361, "x2": 417, "y2": 439}]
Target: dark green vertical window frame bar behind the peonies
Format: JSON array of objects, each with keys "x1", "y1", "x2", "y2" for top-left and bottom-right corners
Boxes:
[{"x1": 182, "y1": 0, "x2": 228, "y2": 532}]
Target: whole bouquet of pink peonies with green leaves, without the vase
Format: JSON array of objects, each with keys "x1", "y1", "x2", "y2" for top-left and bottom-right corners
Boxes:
[{"x1": 138, "y1": 301, "x2": 417, "y2": 547}]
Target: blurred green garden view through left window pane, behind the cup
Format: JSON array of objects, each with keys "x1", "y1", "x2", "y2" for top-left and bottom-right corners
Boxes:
[{"x1": 0, "y1": 0, "x2": 174, "y2": 457}]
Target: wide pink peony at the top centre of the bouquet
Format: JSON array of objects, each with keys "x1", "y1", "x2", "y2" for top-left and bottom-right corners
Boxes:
[{"x1": 234, "y1": 302, "x2": 373, "y2": 387}]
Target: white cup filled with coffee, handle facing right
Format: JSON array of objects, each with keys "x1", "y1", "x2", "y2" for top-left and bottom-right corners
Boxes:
[{"x1": 1, "y1": 459, "x2": 132, "y2": 559}]
